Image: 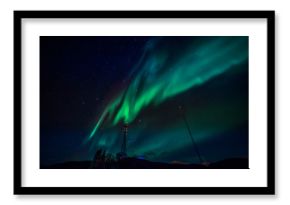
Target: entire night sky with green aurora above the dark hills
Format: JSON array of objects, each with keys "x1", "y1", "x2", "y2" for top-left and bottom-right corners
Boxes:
[{"x1": 40, "y1": 36, "x2": 248, "y2": 165}]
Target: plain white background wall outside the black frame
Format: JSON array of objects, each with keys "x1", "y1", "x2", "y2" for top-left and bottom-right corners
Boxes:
[{"x1": 0, "y1": 0, "x2": 290, "y2": 205}]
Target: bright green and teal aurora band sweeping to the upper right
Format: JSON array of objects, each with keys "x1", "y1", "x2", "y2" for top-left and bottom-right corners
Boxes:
[{"x1": 87, "y1": 36, "x2": 248, "y2": 143}]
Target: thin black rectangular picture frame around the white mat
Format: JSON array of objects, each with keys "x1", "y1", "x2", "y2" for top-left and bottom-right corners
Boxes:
[{"x1": 14, "y1": 11, "x2": 275, "y2": 195}]
